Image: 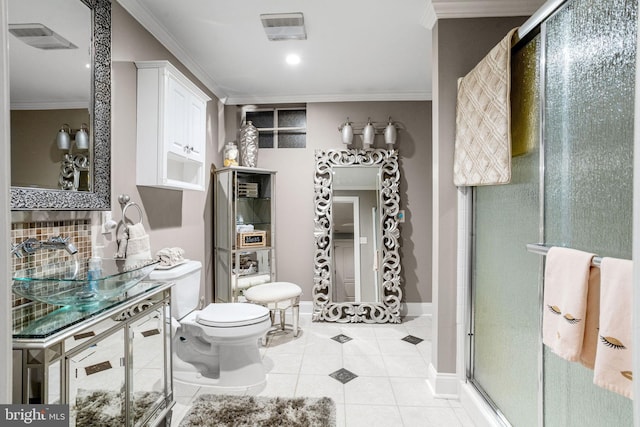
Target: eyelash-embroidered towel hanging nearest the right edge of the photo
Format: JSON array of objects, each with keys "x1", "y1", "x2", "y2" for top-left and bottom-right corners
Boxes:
[{"x1": 593, "y1": 258, "x2": 633, "y2": 398}]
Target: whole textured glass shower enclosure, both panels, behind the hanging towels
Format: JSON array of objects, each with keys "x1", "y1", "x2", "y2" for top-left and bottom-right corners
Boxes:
[{"x1": 468, "y1": 0, "x2": 638, "y2": 427}]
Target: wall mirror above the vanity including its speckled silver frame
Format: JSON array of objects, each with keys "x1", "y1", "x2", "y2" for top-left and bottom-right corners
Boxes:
[{"x1": 8, "y1": 0, "x2": 111, "y2": 210}]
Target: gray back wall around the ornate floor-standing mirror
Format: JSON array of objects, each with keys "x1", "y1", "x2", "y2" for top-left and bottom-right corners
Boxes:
[{"x1": 225, "y1": 101, "x2": 432, "y2": 302}]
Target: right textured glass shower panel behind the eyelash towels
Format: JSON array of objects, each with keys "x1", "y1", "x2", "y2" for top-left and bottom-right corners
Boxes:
[{"x1": 544, "y1": 0, "x2": 637, "y2": 427}]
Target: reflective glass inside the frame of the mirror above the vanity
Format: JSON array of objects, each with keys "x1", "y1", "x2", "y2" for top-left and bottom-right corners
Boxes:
[{"x1": 8, "y1": 0, "x2": 93, "y2": 191}]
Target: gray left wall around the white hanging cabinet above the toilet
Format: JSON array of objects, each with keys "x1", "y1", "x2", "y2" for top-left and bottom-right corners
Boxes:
[{"x1": 111, "y1": 2, "x2": 219, "y2": 300}]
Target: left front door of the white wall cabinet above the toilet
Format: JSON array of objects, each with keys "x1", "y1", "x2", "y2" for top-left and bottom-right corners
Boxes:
[{"x1": 165, "y1": 74, "x2": 191, "y2": 157}]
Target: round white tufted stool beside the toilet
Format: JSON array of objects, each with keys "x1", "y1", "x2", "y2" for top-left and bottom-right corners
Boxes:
[{"x1": 244, "y1": 282, "x2": 302, "y2": 337}]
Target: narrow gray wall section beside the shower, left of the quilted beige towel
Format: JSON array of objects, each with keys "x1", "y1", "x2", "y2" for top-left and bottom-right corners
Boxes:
[{"x1": 432, "y1": 17, "x2": 526, "y2": 373}]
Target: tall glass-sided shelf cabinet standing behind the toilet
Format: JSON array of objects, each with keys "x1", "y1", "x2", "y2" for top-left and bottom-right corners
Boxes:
[{"x1": 214, "y1": 166, "x2": 276, "y2": 302}]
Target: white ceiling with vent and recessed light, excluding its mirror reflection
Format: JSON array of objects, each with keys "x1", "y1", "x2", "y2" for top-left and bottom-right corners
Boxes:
[{"x1": 118, "y1": 0, "x2": 543, "y2": 104}]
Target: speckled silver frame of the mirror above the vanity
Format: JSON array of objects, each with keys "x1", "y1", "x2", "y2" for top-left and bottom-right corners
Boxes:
[{"x1": 11, "y1": 0, "x2": 111, "y2": 210}]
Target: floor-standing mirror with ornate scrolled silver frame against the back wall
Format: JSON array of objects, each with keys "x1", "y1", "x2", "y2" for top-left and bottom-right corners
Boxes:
[{"x1": 313, "y1": 149, "x2": 402, "y2": 323}]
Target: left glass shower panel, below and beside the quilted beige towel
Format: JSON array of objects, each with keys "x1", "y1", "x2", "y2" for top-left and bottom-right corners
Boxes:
[{"x1": 470, "y1": 38, "x2": 540, "y2": 426}]
